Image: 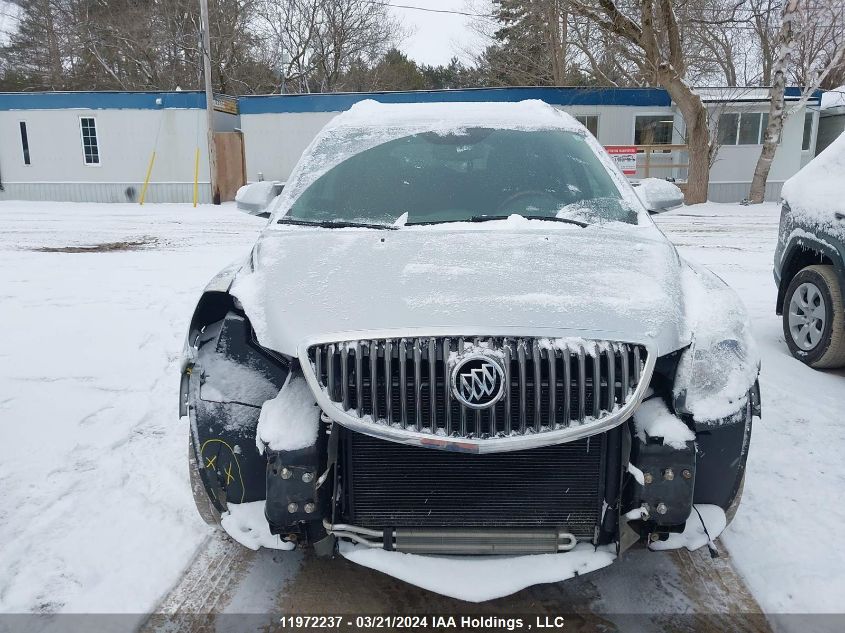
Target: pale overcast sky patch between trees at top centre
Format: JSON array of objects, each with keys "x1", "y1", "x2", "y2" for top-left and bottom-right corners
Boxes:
[{"x1": 388, "y1": 0, "x2": 485, "y2": 65}]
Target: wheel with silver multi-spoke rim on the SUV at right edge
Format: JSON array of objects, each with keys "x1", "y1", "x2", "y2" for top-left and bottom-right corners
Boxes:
[{"x1": 782, "y1": 265, "x2": 845, "y2": 369}]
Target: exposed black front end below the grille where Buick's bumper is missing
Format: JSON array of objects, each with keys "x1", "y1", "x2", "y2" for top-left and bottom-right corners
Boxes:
[{"x1": 180, "y1": 307, "x2": 759, "y2": 572}]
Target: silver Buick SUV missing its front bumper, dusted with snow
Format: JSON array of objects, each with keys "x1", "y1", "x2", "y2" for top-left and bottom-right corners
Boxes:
[{"x1": 181, "y1": 101, "x2": 759, "y2": 599}]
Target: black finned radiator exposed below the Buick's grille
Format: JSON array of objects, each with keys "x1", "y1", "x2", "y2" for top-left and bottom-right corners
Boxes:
[{"x1": 341, "y1": 431, "x2": 606, "y2": 540}]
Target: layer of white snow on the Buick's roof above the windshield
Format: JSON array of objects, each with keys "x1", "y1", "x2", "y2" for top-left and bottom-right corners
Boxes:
[{"x1": 325, "y1": 99, "x2": 584, "y2": 132}]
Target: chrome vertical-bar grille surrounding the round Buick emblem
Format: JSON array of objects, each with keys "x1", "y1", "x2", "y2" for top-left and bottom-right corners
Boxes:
[{"x1": 308, "y1": 336, "x2": 651, "y2": 440}]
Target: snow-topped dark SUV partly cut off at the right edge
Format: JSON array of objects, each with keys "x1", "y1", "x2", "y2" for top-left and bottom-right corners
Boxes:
[{"x1": 774, "y1": 134, "x2": 845, "y2": 369}]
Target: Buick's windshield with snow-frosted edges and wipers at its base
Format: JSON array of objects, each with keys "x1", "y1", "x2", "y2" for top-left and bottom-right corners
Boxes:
[{"x1": 283, "y1": 128, "x2": 637, "y2": 224}]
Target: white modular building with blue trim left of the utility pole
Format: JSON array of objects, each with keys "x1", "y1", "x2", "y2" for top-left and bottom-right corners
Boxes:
[{"x1": 0, "y1": 92, "x2": 238, "y2": 202}]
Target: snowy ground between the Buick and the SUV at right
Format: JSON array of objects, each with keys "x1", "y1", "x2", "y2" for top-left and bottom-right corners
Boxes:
[{"x1": 658, "y1": 203, "x2": 845, "y2": 613}]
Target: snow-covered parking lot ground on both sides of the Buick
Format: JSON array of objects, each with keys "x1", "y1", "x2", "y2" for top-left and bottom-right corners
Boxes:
[{"x1": 0, "y1": 202, "x2": 845, "y2": 630}]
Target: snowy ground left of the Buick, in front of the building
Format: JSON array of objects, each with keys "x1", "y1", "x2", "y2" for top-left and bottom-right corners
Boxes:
[{"x1": 0, "y1": 202, "x2": 263, "y2": 613}]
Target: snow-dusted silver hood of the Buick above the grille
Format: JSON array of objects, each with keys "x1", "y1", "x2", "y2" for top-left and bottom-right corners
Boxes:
[{"x1": 231, "y1": 221, "x2": 688, "y2": 355}]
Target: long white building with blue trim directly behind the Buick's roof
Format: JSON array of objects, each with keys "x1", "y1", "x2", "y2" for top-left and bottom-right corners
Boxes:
[{"x1": 239, "y1": 87, "x2": 820, "y2": 202}]
